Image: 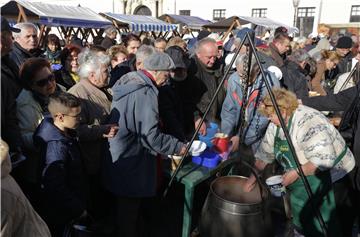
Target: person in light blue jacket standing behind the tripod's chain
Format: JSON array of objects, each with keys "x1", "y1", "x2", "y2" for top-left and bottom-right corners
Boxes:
[{"x1": 221, "y1": 54, "x2": 280, "y2": 151}]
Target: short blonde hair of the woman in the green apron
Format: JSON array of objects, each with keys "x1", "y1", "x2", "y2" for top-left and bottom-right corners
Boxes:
[{"x1": 259, "y1": 88, "x2": 299, "y2": 117}]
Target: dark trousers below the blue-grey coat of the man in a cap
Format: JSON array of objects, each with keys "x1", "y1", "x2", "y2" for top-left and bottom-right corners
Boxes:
[{"x1": 116, "y1": 197, "x2": 159, "y2": 237}]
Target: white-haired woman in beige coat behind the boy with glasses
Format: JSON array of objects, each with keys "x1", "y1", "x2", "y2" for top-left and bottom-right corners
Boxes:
[{"x1": 68, "y1": 49, "x2": 117, "y2": 216}]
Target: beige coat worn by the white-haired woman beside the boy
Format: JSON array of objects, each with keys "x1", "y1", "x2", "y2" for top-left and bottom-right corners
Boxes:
[{"x1": 68, "y1": 79, "x2": 111, "y2": 174}]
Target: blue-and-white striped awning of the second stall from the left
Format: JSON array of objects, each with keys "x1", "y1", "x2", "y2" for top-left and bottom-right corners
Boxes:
[{"x1": 101, "y1": 12, "x2": 176, "y2": 32}]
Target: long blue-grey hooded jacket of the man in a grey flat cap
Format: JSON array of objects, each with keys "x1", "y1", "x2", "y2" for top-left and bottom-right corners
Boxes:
[{"x1": 104, "y1": 71, "x2": 183, "y2": 197}]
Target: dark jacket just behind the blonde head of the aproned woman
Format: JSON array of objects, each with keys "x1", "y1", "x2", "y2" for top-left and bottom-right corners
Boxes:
[{"x1": 280, "y1": 60, "x2": 309, "y2": 99}]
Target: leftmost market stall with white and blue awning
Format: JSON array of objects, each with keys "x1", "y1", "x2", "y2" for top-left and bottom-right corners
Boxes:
[{"x1": 1, "y1": 0, "x2": 111, "y2": 45}]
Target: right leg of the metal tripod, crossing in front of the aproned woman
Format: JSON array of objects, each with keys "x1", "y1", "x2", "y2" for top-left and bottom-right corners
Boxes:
[{"x1": 245, "y1": 32, "x2": 328, "y2": 237}]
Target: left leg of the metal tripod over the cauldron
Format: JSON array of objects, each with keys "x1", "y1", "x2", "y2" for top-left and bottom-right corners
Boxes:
[{"x1": 163, "y1": 37, "x2": 246, "y2": 197}]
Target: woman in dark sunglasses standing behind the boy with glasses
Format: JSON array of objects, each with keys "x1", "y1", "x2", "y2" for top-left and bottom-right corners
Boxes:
[{"x1": 16, "y1": 58, "x2": 60, "y2": 187}]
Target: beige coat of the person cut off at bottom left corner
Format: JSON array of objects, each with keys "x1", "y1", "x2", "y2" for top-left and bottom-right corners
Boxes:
[{"x1": 0, "y1": 140, "x2": 51, "y2": 237}]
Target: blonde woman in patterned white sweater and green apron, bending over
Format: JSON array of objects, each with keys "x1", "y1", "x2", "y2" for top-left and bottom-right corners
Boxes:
[{"x1": 246, "y1": 89, "x2": 355, "y2": 236}]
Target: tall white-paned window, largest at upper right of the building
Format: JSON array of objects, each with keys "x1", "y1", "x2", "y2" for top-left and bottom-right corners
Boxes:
[{"x1": 296, "y1": 7, "x2": 315, "y2": 36}]
